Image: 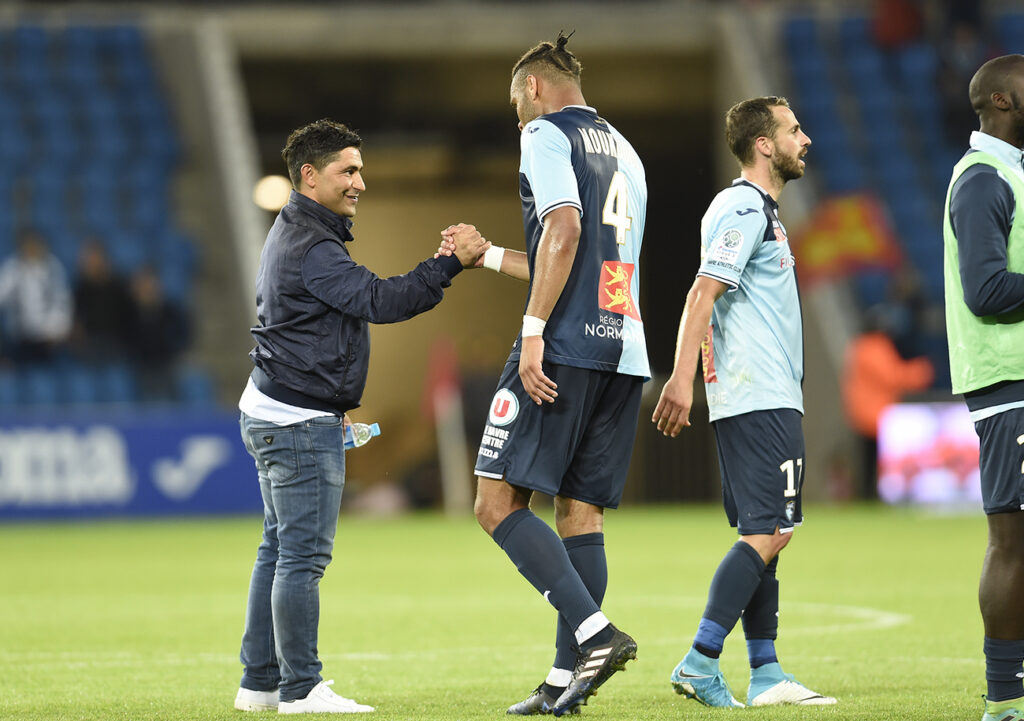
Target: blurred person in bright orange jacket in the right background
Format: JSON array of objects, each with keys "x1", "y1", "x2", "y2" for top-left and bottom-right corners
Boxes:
[{"x1": 843, "y1": 306, "x2": 934, "y2": 498}]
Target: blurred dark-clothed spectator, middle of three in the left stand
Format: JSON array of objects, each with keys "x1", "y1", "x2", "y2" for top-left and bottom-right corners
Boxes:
[{"x1": 72, "y1": 239, "x2": 132, "y2": 363}]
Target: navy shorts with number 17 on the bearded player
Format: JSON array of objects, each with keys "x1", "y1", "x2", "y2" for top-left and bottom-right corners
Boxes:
[{"x1": 712, "y1": 409, "x2": 804, "y2": 536}]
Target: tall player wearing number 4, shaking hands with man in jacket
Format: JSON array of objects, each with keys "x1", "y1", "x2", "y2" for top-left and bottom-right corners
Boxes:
[{"x1": 440, "y1": 35, "x2": 650, "y2": 716}]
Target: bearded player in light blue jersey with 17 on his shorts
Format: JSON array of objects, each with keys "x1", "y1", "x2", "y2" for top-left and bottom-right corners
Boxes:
[{"x1": 652, "y1": 96, "x2": 836, "y2": 707}]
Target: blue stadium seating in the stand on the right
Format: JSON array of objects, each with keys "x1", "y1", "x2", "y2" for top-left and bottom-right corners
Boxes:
[{"x1": 781, "y1": 11, "x2": 962, "y2": 384}]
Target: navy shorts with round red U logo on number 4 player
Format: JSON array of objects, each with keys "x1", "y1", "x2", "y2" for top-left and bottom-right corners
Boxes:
[{"x1": 476, "y1": 361, "x2": 643, "y2": 508}]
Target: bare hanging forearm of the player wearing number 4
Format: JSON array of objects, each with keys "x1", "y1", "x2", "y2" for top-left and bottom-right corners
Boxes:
[{"x1": 526, "y1": 208, "x2": 580, "y2": 321}]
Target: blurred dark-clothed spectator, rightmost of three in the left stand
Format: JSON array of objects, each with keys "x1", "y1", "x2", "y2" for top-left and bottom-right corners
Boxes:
[{"x1": 127, "y1": 266, "x2": 191, "y2": 401}]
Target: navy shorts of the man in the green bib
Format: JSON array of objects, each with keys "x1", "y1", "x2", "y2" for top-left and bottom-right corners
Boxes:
[{"x1": 974, "y1": 408, "x2": 1024, "y2": 514}]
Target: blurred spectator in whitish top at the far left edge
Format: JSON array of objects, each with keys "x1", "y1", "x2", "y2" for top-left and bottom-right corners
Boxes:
[{"x1": 0, "y1": 230, "x2": 72, "y2": 364}]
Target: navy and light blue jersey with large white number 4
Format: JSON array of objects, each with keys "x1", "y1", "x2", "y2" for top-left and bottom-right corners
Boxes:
[{"x1": 509, "y1": 105, "x2": 650, "y2": 379}]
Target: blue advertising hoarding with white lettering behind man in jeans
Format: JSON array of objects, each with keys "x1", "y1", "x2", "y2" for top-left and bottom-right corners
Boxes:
[{"x1": 0, "y1": 409, "x2": 263, "y2": 520}]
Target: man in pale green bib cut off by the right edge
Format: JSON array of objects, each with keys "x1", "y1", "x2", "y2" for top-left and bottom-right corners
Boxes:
[{"x1": 943, "y1": 55, "x2": 1024, "y2": 721}]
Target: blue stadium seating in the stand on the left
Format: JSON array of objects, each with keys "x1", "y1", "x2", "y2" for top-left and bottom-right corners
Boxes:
[{"x1": 0, "y1": 23, "x2": 203, "y2": 409}]
